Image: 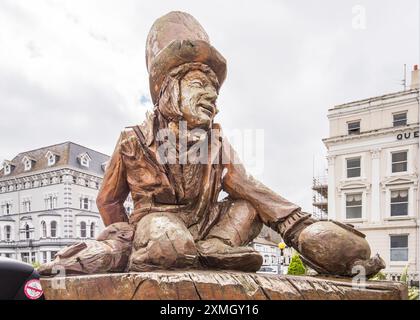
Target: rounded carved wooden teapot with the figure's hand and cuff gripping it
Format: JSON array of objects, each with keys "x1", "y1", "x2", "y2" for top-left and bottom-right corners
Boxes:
[{"x1": 279, "y1": 211, "x2": 385, "y2": 277}]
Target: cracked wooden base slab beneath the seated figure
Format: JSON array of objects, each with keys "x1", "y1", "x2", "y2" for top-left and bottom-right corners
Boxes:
[{"x1": 41, "y1": 271, "x2": 407, "y2": 300}]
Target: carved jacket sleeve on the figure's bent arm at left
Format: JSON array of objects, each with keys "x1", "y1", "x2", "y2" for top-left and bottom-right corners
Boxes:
[{"x1": 96, "y1": 132, "x2": 129, "y2": 226}]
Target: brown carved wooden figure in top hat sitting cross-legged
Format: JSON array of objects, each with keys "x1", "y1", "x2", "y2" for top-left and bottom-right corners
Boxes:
[{"x1": 40, "y1": 12, "x2": 384, "y2": 276}]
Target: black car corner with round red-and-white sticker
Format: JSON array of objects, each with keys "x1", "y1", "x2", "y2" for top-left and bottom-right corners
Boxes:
[{"x1": 0, "y1": 257, "x2": 44, "y2": 300}]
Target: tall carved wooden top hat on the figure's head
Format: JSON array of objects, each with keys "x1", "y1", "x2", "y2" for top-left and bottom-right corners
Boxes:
[{"x1": 146, "y1": 11, "x2": 226, "y2": 104}]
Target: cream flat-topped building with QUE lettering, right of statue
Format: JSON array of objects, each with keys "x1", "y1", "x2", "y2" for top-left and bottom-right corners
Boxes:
[{"x1": 324, "y1": 66, "x2": 420, "y2": 279}]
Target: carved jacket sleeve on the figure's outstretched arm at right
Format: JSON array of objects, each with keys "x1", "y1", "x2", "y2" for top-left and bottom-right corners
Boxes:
[{"x1": 222, "y1": 139, "x2": 300, "y2": 226}]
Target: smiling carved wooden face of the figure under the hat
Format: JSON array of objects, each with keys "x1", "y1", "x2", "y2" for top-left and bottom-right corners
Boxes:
[{"x1": 180, "y1": 70, "x2": 218, "y2": 129}]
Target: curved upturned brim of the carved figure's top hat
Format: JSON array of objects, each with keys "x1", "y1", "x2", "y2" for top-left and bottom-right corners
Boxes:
[{"x1": 149, "y1": 40, "x2": 227, "y2": 104}]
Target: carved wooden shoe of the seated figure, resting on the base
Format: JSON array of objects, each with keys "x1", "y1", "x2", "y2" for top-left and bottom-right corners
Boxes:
[{"x1": 197, "y1": 238, "x2": 263, "y2": 272}]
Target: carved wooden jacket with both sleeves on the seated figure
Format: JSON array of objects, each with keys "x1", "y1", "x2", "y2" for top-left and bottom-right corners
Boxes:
[{"x1": 97, "y1": 117, "x2": 300, "y2": 239}]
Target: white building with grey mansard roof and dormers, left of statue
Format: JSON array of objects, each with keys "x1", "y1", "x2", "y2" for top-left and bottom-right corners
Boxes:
[{"x1": 0, "y1": 142, "x2": 131, "y2": 263}]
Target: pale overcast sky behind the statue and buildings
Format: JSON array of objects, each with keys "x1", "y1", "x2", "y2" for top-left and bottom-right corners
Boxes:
[{"x1": 0, "y1": 0, "x2": 420, "y2": 212}]
